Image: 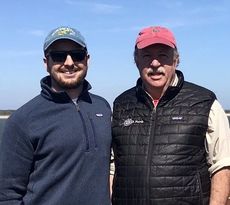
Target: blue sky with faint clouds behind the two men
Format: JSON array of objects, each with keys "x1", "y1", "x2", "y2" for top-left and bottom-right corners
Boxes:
[{"x1": 0, "y1": 0, "x2": 230, "y2": 109}]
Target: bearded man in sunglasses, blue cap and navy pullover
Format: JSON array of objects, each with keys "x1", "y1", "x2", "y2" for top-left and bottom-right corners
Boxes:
[{"x1": 0, "y1": 26, "x2": 111, "y2": 205}]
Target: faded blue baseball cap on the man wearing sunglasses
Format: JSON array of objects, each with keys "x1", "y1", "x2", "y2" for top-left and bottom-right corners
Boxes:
[{"x1": 43, "y1": 26, "x2": 87, "y2": 52}]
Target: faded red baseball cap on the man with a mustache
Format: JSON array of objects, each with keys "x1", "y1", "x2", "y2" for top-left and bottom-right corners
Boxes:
[{"x1": 136, "y1": 26, "x2": 176, "y2": 49}]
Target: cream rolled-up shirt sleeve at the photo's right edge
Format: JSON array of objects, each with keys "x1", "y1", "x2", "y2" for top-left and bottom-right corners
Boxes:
[{"x1": 205, "y1": 100, "x2": 230, "y2": 175}]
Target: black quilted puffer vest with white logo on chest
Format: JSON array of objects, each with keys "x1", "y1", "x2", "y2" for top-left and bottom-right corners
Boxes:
[{"x1": 112, "y1": 71, "x2": 216, "y2": 205}]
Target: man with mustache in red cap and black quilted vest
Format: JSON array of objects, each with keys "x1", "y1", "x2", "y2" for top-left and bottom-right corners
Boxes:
[{"x1": 112, "y1": 26, "x2": 230, "y2": 205}]
